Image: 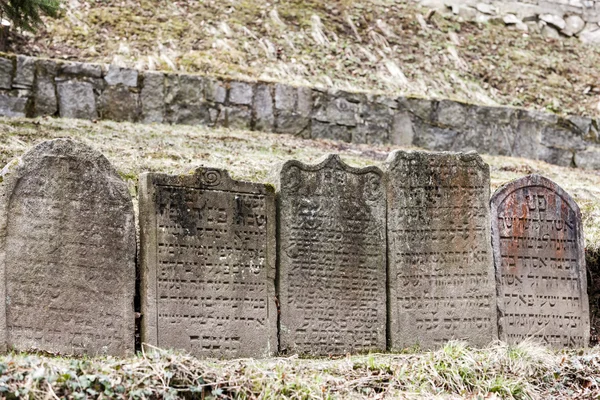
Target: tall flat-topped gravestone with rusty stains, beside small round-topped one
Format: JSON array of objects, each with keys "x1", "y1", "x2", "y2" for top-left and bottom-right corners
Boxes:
[{"x1": 387, "y1": 151, "x2": 498, "y2": 350}]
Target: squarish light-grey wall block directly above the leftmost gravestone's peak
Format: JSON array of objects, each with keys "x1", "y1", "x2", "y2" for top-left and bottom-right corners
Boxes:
[{"x1": 56, "y1": 80, "x2": 98, "y2": 119}]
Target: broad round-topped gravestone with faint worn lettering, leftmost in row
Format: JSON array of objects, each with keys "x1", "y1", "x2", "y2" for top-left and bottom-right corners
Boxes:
[{"x1": 0, "y1": 139, "x2": 136, "y2": 355}]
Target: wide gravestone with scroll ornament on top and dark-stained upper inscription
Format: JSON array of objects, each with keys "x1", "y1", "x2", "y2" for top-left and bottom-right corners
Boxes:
[{"x1": 140, "y1": 168, "x2": 277, "y2": 358}]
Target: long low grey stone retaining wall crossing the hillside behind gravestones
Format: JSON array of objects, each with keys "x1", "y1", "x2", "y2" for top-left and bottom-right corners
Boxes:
[{"x1": 0, "y1": 55, "x2": 600, "y2": 169}]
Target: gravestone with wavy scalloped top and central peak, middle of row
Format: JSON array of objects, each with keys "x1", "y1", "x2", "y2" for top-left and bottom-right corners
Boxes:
[{"x1": 278, "y1": 155, "x2": 386, "y2": 355}]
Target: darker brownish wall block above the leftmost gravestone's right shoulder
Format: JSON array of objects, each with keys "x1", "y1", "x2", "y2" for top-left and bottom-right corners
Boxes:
[{"x1": 100, "y1": 85, "x2": 141, "y2": 122}]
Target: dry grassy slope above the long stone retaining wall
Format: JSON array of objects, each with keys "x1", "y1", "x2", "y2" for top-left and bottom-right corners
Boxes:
[{"x1": 13, "y1": 0, "x2": 600, "y2": 116}]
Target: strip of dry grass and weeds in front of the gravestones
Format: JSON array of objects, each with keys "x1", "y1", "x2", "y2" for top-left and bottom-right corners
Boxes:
[{"x1": 0, "y1": 342, "x2": 600, "y2": 399}]
